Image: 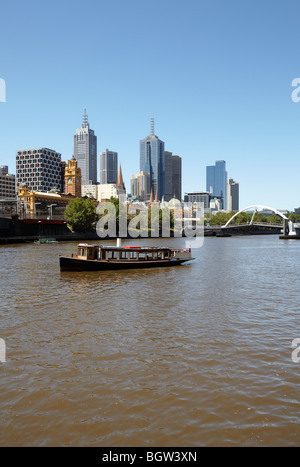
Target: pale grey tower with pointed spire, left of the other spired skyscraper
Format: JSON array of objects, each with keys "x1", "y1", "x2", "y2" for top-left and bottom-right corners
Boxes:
[{"x1": 74, "y1": 109, "x2": 97, "y2": 185}]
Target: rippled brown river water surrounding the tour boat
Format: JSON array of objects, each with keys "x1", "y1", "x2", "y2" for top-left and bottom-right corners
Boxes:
[{"x1": 0, "y1": 236, "x2": 300, "y2": 447}]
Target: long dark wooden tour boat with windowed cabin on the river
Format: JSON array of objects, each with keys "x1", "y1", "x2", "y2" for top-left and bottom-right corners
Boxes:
[{"x1": 59, "y1": 243, "x2": 194, "y2": 271}]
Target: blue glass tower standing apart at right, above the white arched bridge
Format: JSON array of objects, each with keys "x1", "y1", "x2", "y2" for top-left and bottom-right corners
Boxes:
[{"x1": 206, "y1": 161, "x2": 227, "y2": 209}]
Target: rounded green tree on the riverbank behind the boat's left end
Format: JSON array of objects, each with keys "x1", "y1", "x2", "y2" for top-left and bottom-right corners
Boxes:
[{"x1": 65, "y1": 198, "x2": 98, "y2": 232}]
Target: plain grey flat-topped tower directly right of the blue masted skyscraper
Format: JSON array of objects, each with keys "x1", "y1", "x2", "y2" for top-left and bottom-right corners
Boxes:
[{"x1": 164, "y1": 151, "x2": 182, "y2": 201}]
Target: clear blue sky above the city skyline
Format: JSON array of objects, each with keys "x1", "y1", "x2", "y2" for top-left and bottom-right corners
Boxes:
[{"x1": 0, "y1": 0, "x2": 300, "y2": 210}]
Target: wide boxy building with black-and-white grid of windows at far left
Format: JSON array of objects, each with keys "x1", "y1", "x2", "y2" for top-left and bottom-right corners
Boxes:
[{"x1": 16, "y1": 148, "x2": 62, "y2": 192}]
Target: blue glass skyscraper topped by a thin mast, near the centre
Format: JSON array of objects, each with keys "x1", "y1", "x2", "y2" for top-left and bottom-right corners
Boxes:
[{"x1": 140, "y1": 118, "x2": 165, "y2": 201}]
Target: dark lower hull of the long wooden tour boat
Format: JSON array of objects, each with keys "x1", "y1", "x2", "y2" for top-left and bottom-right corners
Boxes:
[{"x1": 59, "y1": 256, "x2": 193, "y2": 271}]
